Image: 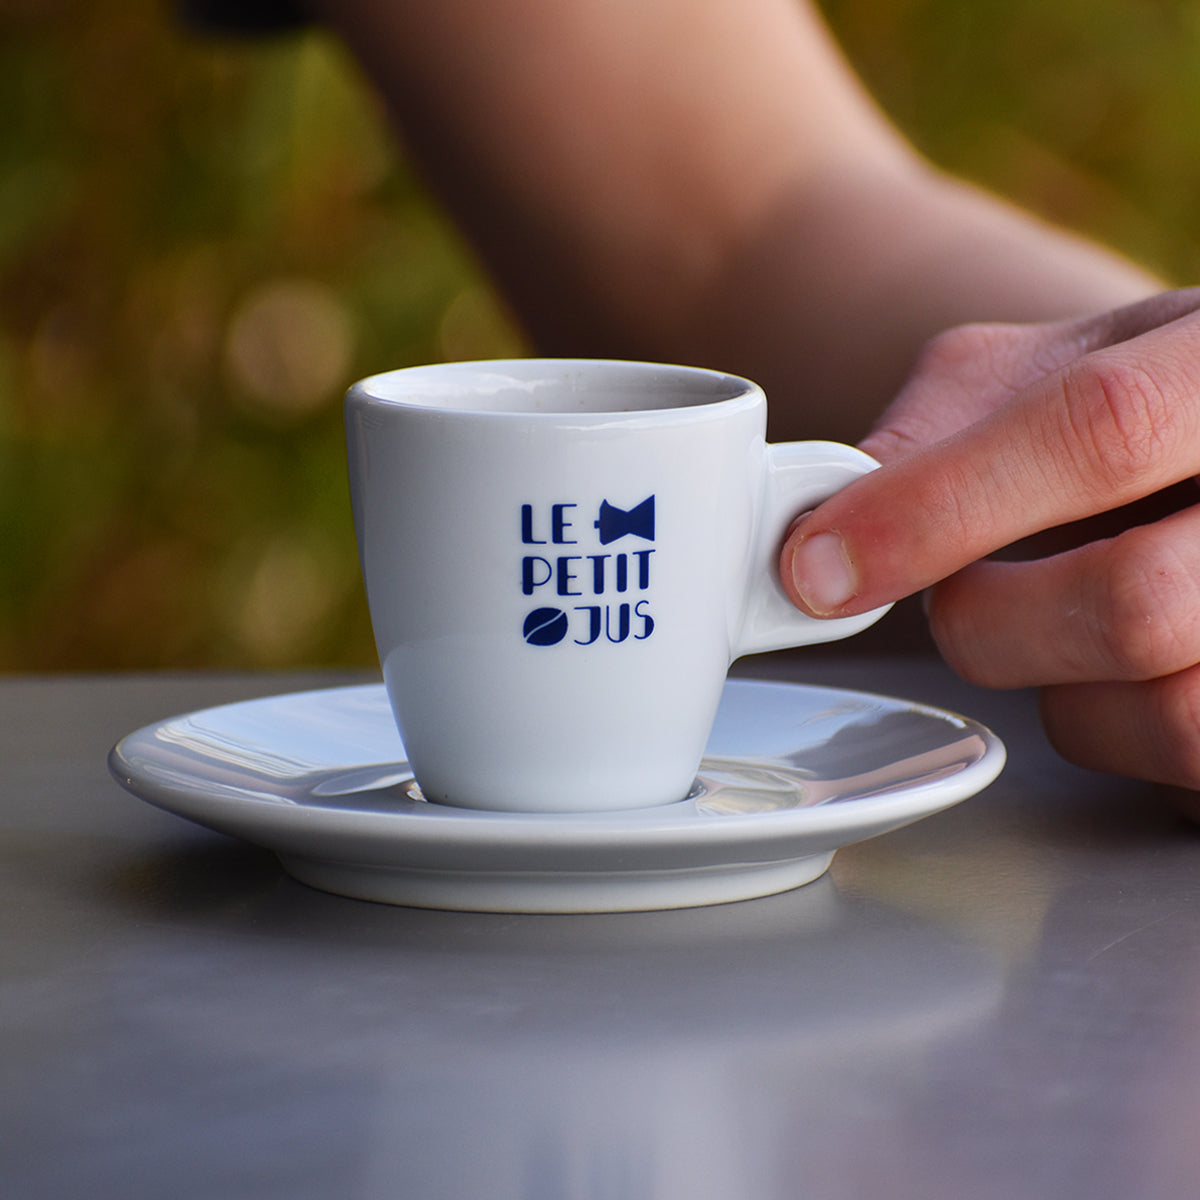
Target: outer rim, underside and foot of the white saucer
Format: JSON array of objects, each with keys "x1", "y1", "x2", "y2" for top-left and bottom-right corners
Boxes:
[{"x1": 108, "y1": 678, "x2": 1006, "y2": 912}]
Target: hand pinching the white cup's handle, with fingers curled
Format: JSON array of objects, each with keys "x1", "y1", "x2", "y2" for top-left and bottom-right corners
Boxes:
[{"x1": 781, "y1": 289, "x2": 1200, "y2": 790}]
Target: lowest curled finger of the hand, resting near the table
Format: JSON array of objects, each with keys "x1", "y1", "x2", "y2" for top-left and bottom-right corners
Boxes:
[{"x1": 1042, "y1": 666, "x2": 1200, "y2": 791}]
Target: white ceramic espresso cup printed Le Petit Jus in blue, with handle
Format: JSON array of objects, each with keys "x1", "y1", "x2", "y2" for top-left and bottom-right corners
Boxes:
[{"x1": 346, "y1": 359, "x2": 884, "y2": 812}]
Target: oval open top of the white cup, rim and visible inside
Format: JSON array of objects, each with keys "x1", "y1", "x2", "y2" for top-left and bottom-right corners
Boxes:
[{"x1": 347, "y1": 358, "x2": 766, "y2": 424}]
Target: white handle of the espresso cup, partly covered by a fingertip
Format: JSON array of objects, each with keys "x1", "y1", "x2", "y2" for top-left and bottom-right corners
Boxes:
[{"x1": 732, "y1": 442, "x2": 892, "y2": 658}]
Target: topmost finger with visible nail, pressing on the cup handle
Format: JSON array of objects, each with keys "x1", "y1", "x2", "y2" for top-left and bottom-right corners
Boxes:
[{"x1": 780, "y1": 316, "x2": 1200, "y2": 617}]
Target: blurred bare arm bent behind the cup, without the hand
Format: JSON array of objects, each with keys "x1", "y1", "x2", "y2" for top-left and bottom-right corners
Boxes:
[{"x1": 318, "y1": 0, "x2": 1152, "y2": 438}]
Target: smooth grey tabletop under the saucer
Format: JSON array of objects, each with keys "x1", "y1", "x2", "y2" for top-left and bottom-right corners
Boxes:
[{"x1": 0, "y1": 655, "x2": 1200, "y2": 1200}]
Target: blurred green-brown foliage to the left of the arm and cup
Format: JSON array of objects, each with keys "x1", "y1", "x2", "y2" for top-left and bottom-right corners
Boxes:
[{"x1": 0, "y1": 0, "x2": 520, "y2": 670}]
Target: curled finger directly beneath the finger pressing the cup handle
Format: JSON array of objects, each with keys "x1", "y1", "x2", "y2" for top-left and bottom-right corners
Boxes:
[{"x1": 929, "y1": 506, "x2": 1200, "y2": 688}]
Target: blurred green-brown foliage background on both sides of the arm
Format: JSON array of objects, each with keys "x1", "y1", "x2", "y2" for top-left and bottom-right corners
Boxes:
[{"x1": 0, "y1": 0, "x2": 1200, "y2": 671}]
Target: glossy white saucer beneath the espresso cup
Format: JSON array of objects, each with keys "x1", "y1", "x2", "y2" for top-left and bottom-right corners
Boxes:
[{"x1": 109, "y1": 679, "x2": 1004, "y2": 912}]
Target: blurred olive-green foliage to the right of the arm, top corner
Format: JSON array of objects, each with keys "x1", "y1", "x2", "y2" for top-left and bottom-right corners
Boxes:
[{"x1": 822, "y1": 0, "x2": 1200, "y2": 283}]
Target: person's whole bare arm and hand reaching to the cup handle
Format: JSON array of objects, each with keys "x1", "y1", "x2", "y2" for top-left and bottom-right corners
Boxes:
[{"x1": 313, "y1": 0, "x2": 1200, "y2": 788}]
